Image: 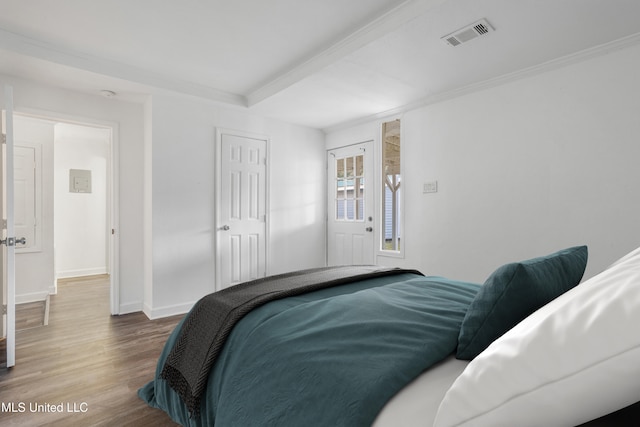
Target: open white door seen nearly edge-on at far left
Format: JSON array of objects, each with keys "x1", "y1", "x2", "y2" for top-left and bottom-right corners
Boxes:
[{"x1": 0, "y1": 86, "x2": 16, "y2": 367}]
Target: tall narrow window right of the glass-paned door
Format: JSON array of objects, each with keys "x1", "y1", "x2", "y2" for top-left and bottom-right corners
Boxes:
[{"x1": 381, "y1": 120, "x2": 402, "y2": 252}]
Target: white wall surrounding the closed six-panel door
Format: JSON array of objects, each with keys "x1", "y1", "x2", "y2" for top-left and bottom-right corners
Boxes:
[{"x1": 144, "y1": 94, "x2": 325, "y2": 317}]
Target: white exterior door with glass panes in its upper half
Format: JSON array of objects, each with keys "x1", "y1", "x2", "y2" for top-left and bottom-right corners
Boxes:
[{"x1": 327, "y1": 141, "x2": 375, "y2": 266}]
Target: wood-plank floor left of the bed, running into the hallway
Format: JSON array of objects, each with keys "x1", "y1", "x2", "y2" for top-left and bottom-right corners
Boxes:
[{"x1": 0, "y1": 276, "x2": 179, "y2": 427}]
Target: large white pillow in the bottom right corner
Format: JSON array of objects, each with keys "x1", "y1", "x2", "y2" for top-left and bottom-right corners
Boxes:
[{"x1": 434, "y1": 248, "x2": 640, "y2": 427}]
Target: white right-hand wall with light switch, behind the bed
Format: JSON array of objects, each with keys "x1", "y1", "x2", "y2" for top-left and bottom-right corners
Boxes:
[{"x1": 327, "y1": 46, "x2": 640, "y2": 282}]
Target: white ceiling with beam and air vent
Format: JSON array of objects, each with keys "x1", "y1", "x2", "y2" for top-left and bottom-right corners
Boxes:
[{"x1": 0, "y1": 0, "x2": 640, "y2": 129}]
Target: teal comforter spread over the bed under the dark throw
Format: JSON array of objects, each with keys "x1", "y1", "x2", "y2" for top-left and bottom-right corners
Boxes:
[{"x1": 138, "y1": 274, "x2": 479, "y2": 427}]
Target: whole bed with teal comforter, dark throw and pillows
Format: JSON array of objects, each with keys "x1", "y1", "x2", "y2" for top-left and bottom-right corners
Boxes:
[{"x1": 138, "y1": 246, "x2": 640, "y2": 427}]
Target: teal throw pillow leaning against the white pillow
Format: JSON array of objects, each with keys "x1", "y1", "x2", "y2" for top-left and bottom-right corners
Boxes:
[{"x1": 456, "y1": 246, "x2": 587, "y2": 360}]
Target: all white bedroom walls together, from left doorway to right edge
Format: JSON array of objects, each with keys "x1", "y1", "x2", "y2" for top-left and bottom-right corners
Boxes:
[{"x1": 6, "y1": 41, "x2": 640, "y2": 317}]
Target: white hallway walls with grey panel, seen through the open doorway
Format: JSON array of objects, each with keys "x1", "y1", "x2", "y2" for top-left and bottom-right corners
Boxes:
[{"x1": 14, "y1": 114, "x2": 119, "y2": 314}]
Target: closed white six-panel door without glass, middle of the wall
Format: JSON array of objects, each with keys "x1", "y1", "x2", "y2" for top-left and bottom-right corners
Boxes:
[{"x1": 216, "y1": 131, "x2": 267, "y2": 290}]
